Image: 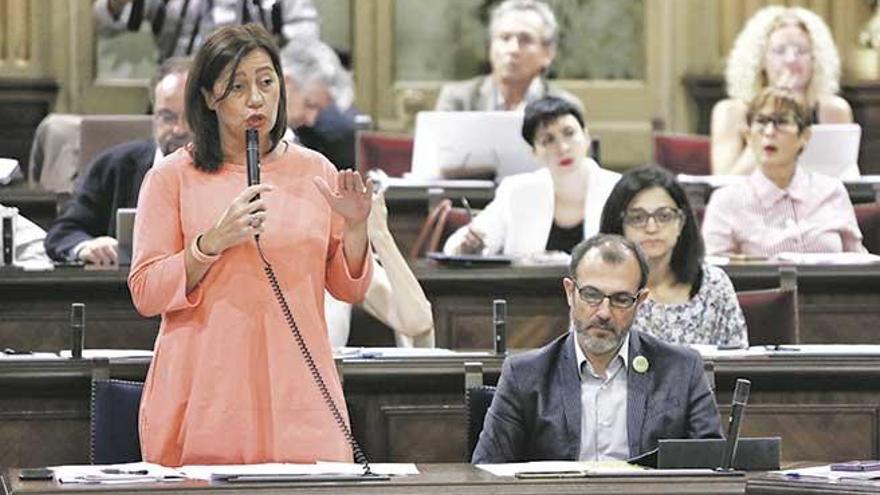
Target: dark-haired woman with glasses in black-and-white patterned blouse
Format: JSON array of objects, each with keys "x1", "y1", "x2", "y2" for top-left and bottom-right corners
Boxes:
[{"x1": 600, "y1": 166, "x2": 748, "y2": 347}]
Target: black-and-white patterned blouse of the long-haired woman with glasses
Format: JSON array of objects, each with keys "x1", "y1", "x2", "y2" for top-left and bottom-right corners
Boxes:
[{"x1": 633, "y1": 264, "x2": 749, "y2": 347}]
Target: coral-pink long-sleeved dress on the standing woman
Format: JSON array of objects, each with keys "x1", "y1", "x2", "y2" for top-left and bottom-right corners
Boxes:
[{"x1": 128, "y1": 145, "x2": 372, "y2": 466}]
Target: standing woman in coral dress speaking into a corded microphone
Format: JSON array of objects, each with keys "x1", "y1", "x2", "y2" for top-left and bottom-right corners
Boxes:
[{"x1": 128, "y1": 24, "x2": 372, "y2": 466}]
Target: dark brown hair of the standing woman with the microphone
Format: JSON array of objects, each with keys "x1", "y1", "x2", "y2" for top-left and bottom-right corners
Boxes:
[{"x1": 186, "y1": 23, "x2": 287, "y2": 172}]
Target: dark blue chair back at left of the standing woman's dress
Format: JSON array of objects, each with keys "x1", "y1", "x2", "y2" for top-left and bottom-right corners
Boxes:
[{"x1": 89, "y1": 380, "x2": 144, "y2": 464}]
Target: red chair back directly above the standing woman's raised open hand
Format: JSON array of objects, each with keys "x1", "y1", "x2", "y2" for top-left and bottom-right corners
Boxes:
[{"x1": 355, "y1": 131, "x2": 413, "y2": 177}]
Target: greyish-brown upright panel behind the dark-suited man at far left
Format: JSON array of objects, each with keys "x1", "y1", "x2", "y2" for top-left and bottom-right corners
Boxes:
[{"x1": 79, "y1": 115, "x2": 153, "y2": 174}]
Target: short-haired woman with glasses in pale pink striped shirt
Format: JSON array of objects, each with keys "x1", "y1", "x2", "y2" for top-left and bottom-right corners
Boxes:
[{"x1": 703, "y1": 88, "x2": 865, "y2": 257}]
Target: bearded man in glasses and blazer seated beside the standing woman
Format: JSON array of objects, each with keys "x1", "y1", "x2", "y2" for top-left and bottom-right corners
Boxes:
[{"x1": 472, "y1": 234, "x2": 721, "y2": 464}]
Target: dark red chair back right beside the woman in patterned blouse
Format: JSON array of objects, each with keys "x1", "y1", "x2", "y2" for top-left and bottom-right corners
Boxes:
[{"x1": 736, "y1": 268, "x2": 800, "y2": 345}]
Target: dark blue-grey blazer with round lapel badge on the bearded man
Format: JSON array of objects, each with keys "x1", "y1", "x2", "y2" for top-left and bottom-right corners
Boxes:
[{"x1": 471, "y1": 330, "x2": 721, "y2": 464}]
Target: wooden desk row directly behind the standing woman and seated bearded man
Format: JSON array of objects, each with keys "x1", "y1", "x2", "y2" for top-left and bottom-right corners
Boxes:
[{"x1": 0, "y1": 354, "x2": 880, "y2": 467}]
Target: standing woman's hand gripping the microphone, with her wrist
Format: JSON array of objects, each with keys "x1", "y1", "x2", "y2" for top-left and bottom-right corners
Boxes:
[{"x1": 198, "y1": 184, "x2": 275, "y2": 255}]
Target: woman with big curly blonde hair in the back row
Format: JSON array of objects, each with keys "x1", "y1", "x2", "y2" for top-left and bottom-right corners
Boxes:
[{"x1": 711, "y1": 6, "x2": 853, "y2": 174}]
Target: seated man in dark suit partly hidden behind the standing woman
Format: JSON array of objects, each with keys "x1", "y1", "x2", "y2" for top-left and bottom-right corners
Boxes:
[{"x1": 45, "y1": 57, "x2": 190, "y2": 265}]
